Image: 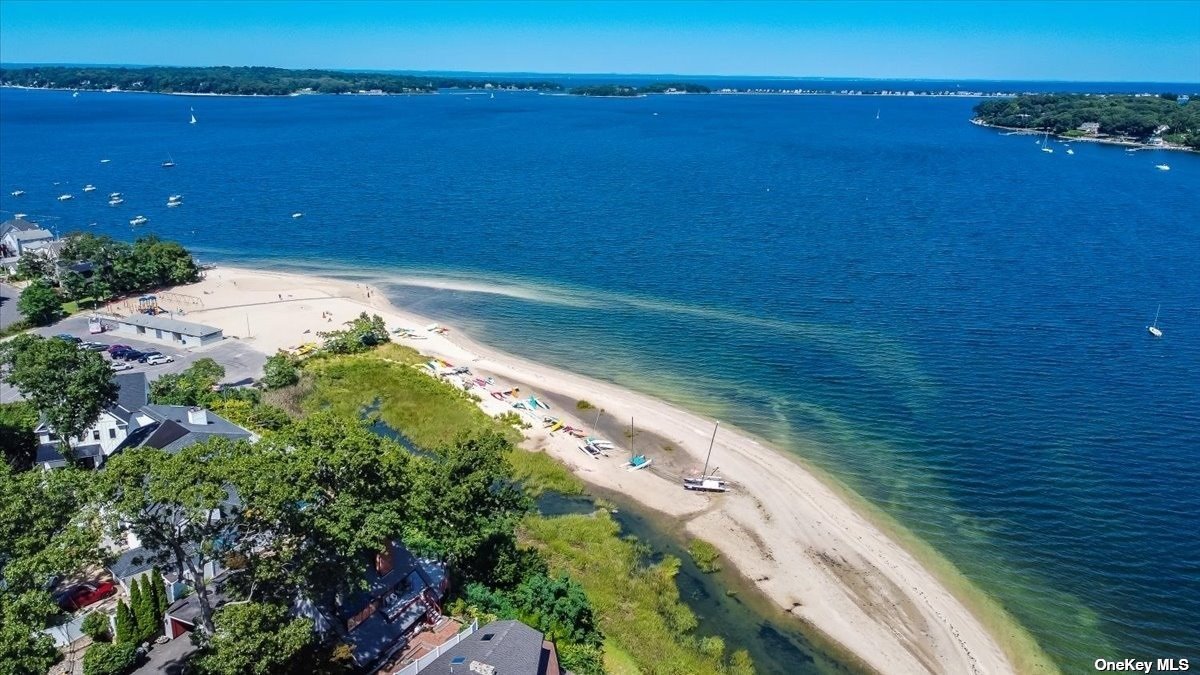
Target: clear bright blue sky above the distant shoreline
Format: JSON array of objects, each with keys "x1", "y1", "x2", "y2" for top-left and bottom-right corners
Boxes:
[{"x1": 0, "y1": 0, "x2": 1200, "y2": 83}]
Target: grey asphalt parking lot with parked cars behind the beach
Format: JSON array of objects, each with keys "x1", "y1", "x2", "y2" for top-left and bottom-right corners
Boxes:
[{"x1": 0, "y1": 315, "x2": 266, "y2": 402}]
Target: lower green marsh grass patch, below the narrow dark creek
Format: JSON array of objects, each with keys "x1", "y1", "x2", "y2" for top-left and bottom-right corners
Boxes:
[{"x1": 520, "y1": 510, "x2": 744, "y2": 675}]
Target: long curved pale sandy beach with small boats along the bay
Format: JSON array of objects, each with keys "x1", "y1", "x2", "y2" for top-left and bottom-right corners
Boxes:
[{"x1": 145, "y1": 267, "x2": 1018, "y2": 675}]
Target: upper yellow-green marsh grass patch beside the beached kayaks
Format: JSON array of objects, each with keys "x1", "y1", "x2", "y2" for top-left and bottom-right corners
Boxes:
[{"x1": 300, "y1": 345, "x2": 521, "y2": 448}]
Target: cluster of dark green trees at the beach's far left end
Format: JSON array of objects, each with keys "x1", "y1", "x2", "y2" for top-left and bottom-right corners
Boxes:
[{"x1": 14, "y1": 232, "x2": 200, "y2": 325}]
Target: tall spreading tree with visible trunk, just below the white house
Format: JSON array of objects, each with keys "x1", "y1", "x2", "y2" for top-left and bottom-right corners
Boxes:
[{"x1": 97, "y1": 438, "x2": 251, "y2": 633}]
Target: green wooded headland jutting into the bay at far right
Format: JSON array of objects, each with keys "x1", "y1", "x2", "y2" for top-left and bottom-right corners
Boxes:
[{"x1": 974, "y1": 94, "x2": 1200, "y2": 149}]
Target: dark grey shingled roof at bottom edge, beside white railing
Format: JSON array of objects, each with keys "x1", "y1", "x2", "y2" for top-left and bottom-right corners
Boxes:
[{"x1": 421, "y1": 620, "x2": 560, "y2": 675}]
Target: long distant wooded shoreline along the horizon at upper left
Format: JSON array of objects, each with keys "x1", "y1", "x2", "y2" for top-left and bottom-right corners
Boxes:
[{"x1": 0, "y1": 66, "x2": 562, "y2": 96}]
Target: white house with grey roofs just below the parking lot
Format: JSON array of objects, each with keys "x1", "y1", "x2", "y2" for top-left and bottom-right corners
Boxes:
[{"x1": 34, "y1": 372, "x2": 256, "y2": 470}]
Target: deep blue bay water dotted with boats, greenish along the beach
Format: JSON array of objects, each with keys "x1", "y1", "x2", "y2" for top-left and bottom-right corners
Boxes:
[{"x1": 0, "y1": 90, "x2": 1200, "y2": 673}]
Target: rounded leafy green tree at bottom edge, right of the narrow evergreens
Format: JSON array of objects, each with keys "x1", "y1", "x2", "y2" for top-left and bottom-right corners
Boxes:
[{"x1": 193, "y1": 602, "x2": 314, "y2": 675}]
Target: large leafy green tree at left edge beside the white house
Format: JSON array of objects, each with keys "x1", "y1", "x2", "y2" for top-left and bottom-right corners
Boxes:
[{"x1": 0, "y1": 335, "x2": 118, "y2": 448}]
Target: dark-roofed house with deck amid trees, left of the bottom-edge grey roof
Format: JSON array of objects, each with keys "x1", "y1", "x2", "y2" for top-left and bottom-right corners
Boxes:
[{"x1": 293, "y1": 542, "x2": 449, "y2": 669}]
